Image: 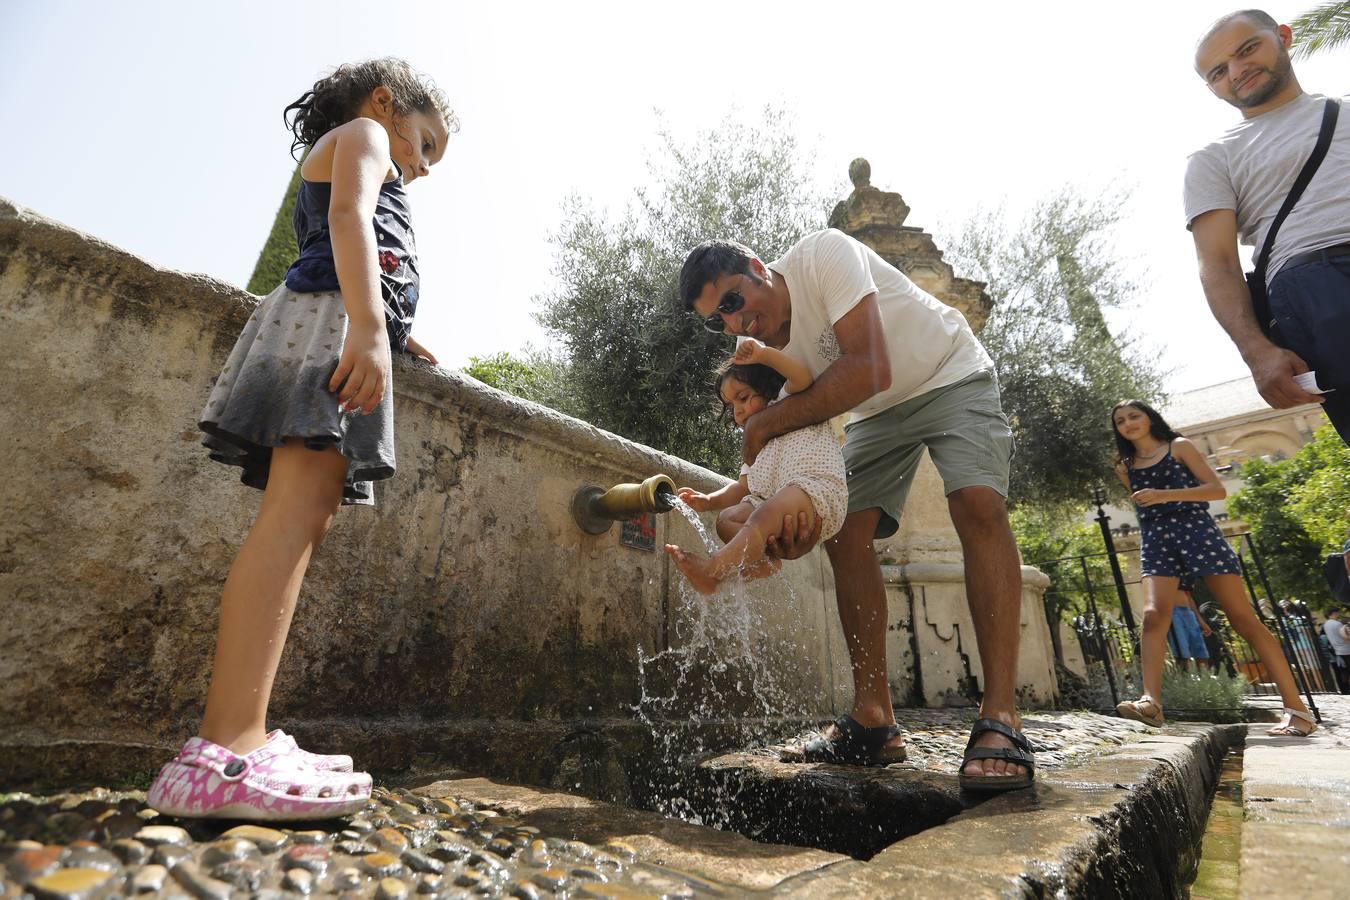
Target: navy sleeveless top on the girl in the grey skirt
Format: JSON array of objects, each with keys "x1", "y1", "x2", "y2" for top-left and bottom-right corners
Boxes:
[{"x1": 286, "y1": 163, "x2": 421, "y2": 351}]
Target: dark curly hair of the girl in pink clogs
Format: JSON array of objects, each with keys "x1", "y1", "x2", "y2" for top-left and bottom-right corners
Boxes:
[{"x1": 282, "y1": 57, "x2": 459, "y2": 157}]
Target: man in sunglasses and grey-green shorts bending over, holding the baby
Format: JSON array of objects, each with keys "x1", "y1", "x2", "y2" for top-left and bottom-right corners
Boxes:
[{"x1": 679, "y1": 229, "x2": 1035, "y2": 791}]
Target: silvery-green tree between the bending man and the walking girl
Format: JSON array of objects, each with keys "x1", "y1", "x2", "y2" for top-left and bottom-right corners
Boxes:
[{"x1": 945, "y1": 190, "x2": 1164, "y2": 507}]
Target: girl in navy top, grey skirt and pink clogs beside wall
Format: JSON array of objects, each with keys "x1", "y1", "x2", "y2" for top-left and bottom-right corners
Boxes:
[{"x1": 147, "y1": 59, "x2": 458, "y2": 820}]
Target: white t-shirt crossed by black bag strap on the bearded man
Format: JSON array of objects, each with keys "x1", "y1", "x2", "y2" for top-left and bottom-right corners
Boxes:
[{"x1": 1185, "y1": 93, "x2": 1350, "y2": 283}]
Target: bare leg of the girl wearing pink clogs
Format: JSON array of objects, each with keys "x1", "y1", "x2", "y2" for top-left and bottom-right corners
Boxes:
[{"x1": 201, "y1": 440, "x2": 347, "y2": 753}]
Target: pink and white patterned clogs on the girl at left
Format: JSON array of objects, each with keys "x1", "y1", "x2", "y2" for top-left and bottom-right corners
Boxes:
[{"x1": 146, "y1": 738, "x2": 371, "y2": 822}]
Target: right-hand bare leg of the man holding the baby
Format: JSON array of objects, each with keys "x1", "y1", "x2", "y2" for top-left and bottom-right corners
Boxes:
[{"x1": 946, "y1": 486, "x2": 1026, "y2": 777}]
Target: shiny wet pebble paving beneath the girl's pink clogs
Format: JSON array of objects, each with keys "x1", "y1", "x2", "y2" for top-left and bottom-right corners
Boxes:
[{"x1": 0, "y1": 788, "x2": 709, "y2": 900}]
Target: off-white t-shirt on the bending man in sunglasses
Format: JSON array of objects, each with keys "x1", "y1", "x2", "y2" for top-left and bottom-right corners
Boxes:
[{"x1": 768, "y1": 228, "x2": 994, "y2": 422}]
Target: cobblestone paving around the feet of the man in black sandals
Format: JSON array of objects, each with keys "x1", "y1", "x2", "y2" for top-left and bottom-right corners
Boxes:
[{"x1": 777, "y1": 710, "x2": 1152, "y2": 773}]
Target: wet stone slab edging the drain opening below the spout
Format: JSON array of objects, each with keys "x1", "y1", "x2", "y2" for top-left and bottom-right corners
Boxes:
[{"x1": 416, "y1": 725, "x2": 1242, "y2": 900}]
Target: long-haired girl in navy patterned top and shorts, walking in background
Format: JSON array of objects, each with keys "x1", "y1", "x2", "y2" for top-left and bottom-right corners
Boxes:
[{"x1": 1111, "y1": 399, "x2": 1316, "y2": 737}]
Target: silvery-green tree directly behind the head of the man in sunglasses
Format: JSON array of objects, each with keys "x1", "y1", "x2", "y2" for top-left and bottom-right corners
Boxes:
[{"x1": 536, "y1": 109, "x2": 826, "y2": 472}]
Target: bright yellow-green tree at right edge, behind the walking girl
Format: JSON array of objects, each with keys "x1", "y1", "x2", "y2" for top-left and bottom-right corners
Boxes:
[{"x1": 1229, "y1": 425, "x2": 1350, "y2": 606}]
